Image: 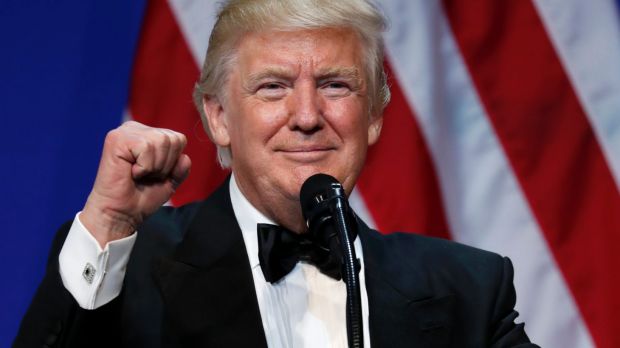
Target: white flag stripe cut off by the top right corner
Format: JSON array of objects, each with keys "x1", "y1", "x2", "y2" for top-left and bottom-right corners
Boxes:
[{"x1": 534, "y1": 0, "x2": 620, "y2": 187}]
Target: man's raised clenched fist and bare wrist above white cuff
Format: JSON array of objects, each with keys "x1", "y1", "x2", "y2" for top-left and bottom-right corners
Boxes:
[{"x1": 80, "y1": 121, "x2": 191, "y2": 248}]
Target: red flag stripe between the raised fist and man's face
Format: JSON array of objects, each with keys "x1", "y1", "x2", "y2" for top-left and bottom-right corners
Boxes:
[{"x1": 129, "y1": 0, "x2": 227, "y2": 205}]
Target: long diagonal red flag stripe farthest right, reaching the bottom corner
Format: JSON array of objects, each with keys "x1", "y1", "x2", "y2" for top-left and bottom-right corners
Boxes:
[{"x1": 444, "y1": 0, "x2": 620, "y2": 347}]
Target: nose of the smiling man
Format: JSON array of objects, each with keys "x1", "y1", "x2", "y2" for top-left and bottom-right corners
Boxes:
[{"x1": 288, "y1": 82, "x2": 323, "y2": 133}]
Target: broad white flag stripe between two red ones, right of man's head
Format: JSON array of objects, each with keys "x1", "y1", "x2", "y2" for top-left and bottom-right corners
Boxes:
[{"x1": 383, "y1": 0, "x2": 593, "y2": 347}]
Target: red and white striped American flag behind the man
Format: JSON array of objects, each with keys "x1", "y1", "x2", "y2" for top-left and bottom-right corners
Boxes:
[{"x1": 129, "y1": 0, "x2": 620, "y2": 348}]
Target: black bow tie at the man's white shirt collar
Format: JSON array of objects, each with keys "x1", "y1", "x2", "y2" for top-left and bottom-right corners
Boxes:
[{"x1": 257, "y1": 224, "x2": 341, "y2": 283}]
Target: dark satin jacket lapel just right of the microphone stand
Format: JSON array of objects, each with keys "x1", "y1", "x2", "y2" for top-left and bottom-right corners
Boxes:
[{"x1": 360, "y1": 223, "x2": 454, "y2": 348}]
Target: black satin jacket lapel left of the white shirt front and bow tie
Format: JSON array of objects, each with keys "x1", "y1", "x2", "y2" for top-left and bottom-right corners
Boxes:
[{"x1": 155, "y1": 181, "x2": 267, "y2": 347}]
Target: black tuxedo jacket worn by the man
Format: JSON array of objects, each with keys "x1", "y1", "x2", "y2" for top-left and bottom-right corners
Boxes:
[{"x1": 14, "y1": 182, "x2": 535, "y2": 348}]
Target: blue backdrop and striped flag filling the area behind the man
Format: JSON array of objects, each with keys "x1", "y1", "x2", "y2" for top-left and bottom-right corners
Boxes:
[{"x1": 0, "y1": 0, "x2": 620, "y2": 348}]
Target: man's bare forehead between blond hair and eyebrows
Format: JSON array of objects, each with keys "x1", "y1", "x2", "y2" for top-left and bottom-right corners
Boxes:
[{"x1": 237, "y1": 28, "x2": 363, "y2": 73}]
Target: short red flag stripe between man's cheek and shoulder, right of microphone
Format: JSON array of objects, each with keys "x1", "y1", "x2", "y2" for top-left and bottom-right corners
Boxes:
[{"x1": 357, "y1": 65, "x2": 450, "y2": 238}]
